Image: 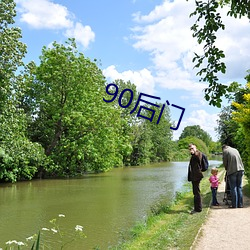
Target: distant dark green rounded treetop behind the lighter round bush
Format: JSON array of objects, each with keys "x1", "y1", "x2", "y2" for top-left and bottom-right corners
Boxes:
[{"x1": 179, "y1": 125, "x2": 212, "y2": 147}]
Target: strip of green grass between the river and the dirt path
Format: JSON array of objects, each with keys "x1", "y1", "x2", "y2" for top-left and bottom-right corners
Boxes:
[{"x1": 111, "y1": 170, "x2": 223, "y2": 250}]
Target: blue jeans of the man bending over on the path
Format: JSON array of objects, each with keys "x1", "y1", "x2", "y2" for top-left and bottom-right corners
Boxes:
[{"x1": 228, "y1": 170, "x2": 244, "y2": 208}]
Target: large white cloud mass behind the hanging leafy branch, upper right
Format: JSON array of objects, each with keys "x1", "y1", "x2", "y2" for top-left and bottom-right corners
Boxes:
[{"x1": 132, "y1": 0, "x2": 250, "y2": 94}]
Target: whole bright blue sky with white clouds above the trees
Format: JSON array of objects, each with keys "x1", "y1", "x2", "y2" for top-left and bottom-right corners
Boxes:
[{"x1": 15, "y1": 0, "x2": 250, "y2": 141}]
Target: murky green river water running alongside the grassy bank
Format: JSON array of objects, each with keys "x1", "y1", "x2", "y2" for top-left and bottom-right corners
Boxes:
[{"x1": 0, "y1": 160, "x2": 221, "y2": 250}]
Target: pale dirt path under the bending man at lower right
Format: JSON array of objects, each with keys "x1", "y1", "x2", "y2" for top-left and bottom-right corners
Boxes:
[{"x1": 191, "y1": 174, "x2": 250, "y2": 250}]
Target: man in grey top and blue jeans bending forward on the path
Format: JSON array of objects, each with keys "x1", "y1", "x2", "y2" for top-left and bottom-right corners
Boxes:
[{"x1": 222, "y1": 145, "x2": 244, "y2": 208}]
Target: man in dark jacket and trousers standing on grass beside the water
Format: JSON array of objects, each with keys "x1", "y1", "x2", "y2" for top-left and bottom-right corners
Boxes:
[{"x1": 188, "y1": 143, "x2": 203, "y2": 214}]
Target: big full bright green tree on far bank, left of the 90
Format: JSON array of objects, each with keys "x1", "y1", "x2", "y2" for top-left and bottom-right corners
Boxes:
[{"x1": 23, "y1": 39, "x2": 127, "y2": 175}]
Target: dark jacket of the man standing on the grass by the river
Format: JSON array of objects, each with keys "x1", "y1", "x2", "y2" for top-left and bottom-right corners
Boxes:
[{"x1": 188, "y1": 150, "x2": 203, "y2": 181}]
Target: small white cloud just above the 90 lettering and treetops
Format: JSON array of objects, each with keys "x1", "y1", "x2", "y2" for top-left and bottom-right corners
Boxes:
[{"x1": 103, "y1": 65, "x2": 155, "y2": 94}]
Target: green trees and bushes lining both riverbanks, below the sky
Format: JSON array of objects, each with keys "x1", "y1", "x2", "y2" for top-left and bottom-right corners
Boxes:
[{"x1": 0, "y1": 0, "x2": 250, "y2": 182}]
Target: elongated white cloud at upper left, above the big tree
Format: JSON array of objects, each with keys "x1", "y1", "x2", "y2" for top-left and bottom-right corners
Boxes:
[{"x1": 16, "y1": 0, "x2": 95, "y2": 48}]
